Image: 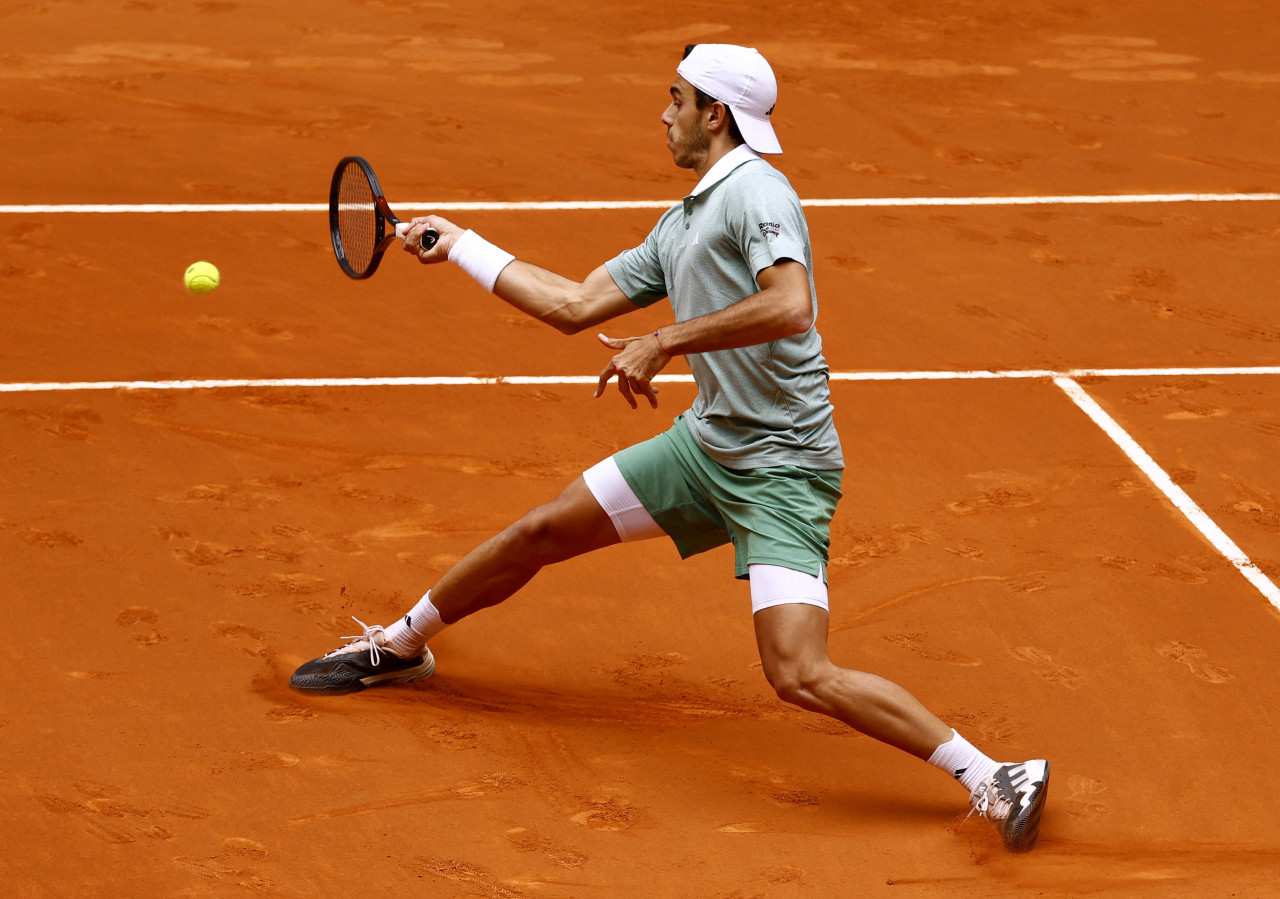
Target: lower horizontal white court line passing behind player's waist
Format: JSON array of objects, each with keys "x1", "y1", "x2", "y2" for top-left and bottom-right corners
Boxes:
[{"x1": 0, "y1": 365, "x2": 1280, "y2": 393}]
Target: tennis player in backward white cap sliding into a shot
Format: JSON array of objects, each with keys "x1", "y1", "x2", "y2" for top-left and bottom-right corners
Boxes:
[{"x1": 291, "y1": 44, "x2": 1048, "y2": 852}]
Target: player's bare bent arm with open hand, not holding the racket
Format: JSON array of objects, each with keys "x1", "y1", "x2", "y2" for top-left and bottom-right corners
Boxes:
[{"x1": 595, "y1": 259, "x2": 813, "y2": 409}]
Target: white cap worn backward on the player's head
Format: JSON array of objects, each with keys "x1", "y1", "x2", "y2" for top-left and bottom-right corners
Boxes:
[{"x1": 676, "y1": 44, "x2": 782, "y2": 152}]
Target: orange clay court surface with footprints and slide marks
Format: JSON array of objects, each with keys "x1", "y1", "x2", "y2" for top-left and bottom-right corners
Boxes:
[{"x1": 0, "y1": 0, "x2": 1280, "y2": 899}]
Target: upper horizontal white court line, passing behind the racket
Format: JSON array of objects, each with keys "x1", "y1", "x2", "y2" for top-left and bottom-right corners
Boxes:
[{"x1": 0, "y1": 193, "x2": 1280, "y2": 215}]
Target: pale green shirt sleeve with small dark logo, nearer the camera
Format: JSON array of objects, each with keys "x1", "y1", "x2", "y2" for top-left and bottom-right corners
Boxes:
[{"x1": 727, "y1": 170, "x2": 813, "y2": 277}]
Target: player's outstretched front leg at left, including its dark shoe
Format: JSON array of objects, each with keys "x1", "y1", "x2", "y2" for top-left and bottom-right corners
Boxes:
[{"x1": 289, "y1": 476, "x2": 621, "y2": 694}]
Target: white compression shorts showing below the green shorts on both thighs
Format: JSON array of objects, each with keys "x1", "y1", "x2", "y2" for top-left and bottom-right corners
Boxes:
[{"x1": 582, "y1": 456, "x2": 829, "y2": 615}]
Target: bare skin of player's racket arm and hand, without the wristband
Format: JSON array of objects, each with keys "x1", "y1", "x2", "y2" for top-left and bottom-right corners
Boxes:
[{"x1": 404, "y1": 215, "x2": 636, "y2": 334}]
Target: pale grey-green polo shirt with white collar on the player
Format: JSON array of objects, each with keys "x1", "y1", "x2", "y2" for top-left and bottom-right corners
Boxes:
[{"x1": 605, "y1": 147, "x2": 845, "y2": 470}]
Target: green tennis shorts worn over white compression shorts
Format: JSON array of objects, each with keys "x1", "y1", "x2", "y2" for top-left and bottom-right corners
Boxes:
[{"x1": 613, "y1": 416, "x2": 842, "y2": 578}]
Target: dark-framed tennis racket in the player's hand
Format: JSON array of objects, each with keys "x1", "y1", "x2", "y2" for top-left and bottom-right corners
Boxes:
[{"x1": 329, "y1": 156, "x2": 440, "y2": 280}]
